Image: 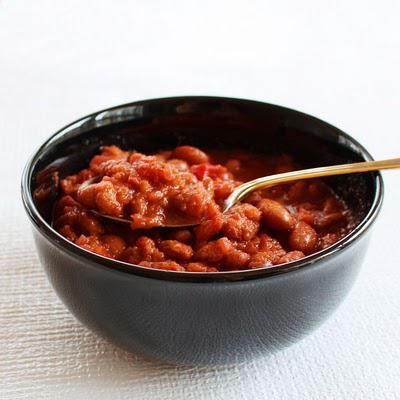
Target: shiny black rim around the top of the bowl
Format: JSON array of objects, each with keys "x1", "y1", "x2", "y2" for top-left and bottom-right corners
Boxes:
[{"x1": 21, "y1": 96, "x2": 384, "y2": 283}]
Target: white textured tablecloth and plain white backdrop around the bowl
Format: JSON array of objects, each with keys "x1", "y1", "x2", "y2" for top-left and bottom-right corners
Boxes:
[{"x1": 0, "y1": 0, "x2": 400, "y2": 400}]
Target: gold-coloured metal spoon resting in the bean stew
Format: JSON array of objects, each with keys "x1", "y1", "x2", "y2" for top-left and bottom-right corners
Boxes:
[{"x1": 85, "y1": 158, "x2": 400, "y2": 228}]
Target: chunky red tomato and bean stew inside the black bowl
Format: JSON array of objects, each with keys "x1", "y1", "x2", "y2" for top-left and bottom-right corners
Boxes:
[{"x1": 54, "y1": 146, "x2": 354, "y2": 272}]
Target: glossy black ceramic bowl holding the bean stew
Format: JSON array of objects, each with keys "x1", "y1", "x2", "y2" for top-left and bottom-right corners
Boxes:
[{"x1": 22, "y1": 97, "x2": 383, "y2": 365}]
